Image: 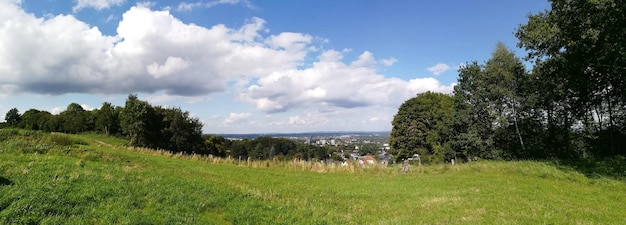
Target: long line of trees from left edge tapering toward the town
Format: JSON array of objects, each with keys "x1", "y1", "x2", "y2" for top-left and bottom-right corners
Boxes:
[{"x1": 4, "y1": 95, "x2": 336, "y2": 160}]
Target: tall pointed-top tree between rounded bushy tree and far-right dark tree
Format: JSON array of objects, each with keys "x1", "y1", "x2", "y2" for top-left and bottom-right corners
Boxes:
[{"x1": 454, "y1": 43, "x2": 529, "y2": 158}]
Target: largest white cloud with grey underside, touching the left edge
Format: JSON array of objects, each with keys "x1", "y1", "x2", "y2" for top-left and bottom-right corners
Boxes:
[{"x1": 0, "y1": 1, "x2": 313, "y2": 96}]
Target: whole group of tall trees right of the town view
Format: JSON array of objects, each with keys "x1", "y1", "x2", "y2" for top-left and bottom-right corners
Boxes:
[{"x1": 390, "y1": 0, "x2": 626, "y2": 161}]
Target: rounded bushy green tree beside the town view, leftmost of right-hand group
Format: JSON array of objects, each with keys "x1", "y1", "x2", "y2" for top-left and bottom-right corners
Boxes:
[{"x1": 389, "y1": 92, "x2": 454, "y2": 161}]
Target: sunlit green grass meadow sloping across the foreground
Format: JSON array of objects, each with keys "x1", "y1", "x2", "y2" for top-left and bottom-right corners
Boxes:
[{"x1": 0, "y1": 129, "x2": 626, "y2": 224}]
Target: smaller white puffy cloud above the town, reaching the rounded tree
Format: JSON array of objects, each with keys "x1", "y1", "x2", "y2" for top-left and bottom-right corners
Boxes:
[{"x1": 242, "y1": 50, "x2": 452, "y2": 113}]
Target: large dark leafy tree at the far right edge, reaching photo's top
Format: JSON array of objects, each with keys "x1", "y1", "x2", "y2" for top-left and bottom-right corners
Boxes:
[{"x1": 515, "y1": 0, "x2": 626, "y2": 155}]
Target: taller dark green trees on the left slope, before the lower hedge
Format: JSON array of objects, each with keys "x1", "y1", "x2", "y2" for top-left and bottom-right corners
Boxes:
[{"x1": 7, "y1": 95, "x2": 209, "y2": 154}]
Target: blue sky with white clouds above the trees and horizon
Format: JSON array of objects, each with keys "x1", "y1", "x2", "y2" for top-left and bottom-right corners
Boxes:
[{"x1": 0, "y1": 0, "x2": 550, "y2": 134}]
